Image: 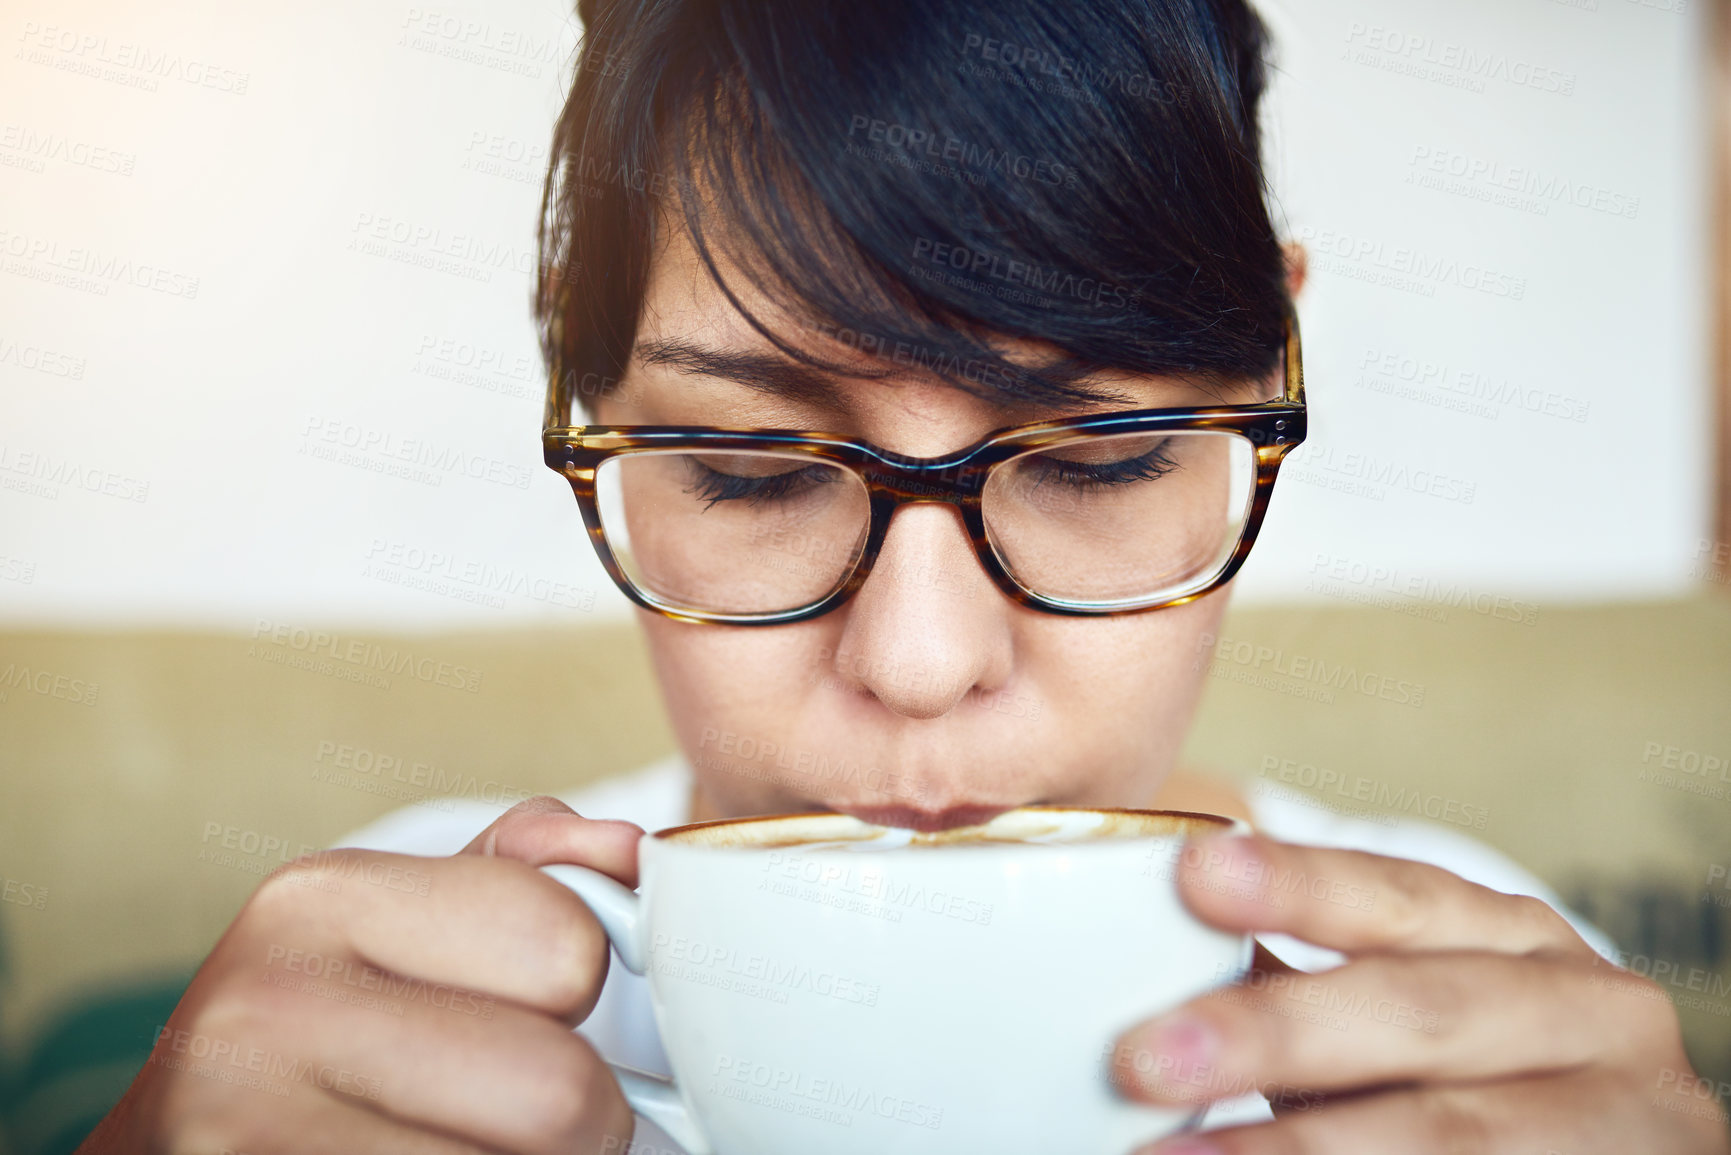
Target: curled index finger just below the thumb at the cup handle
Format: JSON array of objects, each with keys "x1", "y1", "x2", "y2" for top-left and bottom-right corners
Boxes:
[{"x1": 249, "y1": 850, "x2": 608, "y2": 1016}]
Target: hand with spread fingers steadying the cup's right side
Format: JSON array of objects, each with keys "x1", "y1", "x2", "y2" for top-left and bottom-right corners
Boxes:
[{"x1": 1113, "y1": 836, "x2": 1731, "y2": 1155}]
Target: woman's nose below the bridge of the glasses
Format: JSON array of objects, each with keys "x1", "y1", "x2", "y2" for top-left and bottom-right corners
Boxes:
[{"x1": 823, "y1": 502, "x2": 1016, "y2": 719}]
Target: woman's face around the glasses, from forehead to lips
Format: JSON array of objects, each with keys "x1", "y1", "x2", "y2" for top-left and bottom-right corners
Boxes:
[{"x1": 594, "y1": 229, "x2": 1272, "y2": 829}]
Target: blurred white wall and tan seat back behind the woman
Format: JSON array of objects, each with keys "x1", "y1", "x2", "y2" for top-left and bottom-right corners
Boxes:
[{"x1": 0, "y1": 0, "x2": 1731, "y2": 1155}]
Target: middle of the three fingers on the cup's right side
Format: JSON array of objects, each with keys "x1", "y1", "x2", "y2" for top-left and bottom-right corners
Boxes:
[{"x1": 1113, "y1": 952, "x2": 1670, "y2": 1103}]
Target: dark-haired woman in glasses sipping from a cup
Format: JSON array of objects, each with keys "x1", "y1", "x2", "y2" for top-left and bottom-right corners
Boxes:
[{"x1": 83, "y1": 0, "x2": 1728, "y2": 1155}]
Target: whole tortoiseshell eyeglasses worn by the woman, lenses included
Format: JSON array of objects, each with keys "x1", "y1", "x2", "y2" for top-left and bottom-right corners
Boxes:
[{"x1": 542, "y1": 319, "x2": 1305, "y2": 625}]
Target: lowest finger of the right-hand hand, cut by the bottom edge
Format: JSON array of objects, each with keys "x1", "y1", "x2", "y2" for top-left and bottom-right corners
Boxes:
[{"x1": 1137, "y1": 1072, "x2": 1714, "y2": 1155}]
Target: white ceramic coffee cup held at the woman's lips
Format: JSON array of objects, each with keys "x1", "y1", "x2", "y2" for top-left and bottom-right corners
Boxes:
[{"x1": 544, "y1": 807, "x2": 1252, "y2": 1155}]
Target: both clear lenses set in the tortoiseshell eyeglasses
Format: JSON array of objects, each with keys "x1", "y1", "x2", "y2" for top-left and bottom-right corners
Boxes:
[{"x1": 595, "y1": 431, "x2": 1257, "y2": 615}]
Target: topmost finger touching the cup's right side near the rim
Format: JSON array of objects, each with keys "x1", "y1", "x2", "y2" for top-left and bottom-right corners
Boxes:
[{"x1": 1179, "y1": 835, "x2": 1594, "y2": 959}]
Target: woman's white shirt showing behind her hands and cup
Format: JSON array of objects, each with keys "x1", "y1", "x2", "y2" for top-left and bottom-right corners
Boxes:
[{"x1": 336, "y1": 755, "x2": 1617, "y2": 1155}]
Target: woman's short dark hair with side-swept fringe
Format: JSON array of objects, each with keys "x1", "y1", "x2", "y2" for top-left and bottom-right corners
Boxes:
[{"x1": 535, "y1": 0, "x2": 1291, "y2": 413}]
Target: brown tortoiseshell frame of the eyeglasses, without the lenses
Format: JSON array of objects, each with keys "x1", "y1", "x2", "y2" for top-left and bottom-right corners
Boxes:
[{"x1": 542, "y1": 313, "x2": 1307, "y2": 625}]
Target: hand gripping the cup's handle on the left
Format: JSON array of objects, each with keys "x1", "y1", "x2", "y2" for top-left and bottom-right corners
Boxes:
[{"x1": 80, "y1": 798, "x2": 642, "y2": 1155}]
